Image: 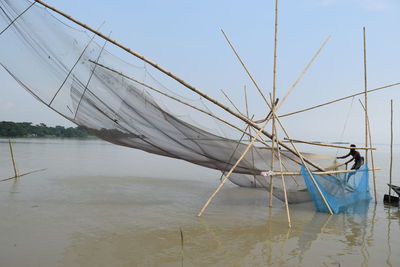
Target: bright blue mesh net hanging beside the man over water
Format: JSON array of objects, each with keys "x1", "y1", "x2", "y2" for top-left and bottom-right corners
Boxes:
[{"x1": 301, "y1": 165, "x2": 371, "y2": 213}]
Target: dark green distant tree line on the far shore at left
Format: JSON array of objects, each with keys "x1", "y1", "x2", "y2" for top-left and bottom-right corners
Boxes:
[{"x1": 0, "y1": 121, "x2": 91, "y2": 138}]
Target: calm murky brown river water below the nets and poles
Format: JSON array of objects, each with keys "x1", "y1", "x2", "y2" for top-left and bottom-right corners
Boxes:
[{"x1": 0, "y1": 139, "x2": 400, "y2": 266}]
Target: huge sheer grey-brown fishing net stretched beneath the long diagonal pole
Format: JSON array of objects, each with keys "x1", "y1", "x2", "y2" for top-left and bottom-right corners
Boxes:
[{"x1": 0, "y1": 0, "x2": 333, "y2": 202}]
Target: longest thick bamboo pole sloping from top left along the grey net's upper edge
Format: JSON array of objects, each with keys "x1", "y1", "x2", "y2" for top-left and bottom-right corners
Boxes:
[{"x1": 35, "y1": 0, "x2": 323, "y2": 174}]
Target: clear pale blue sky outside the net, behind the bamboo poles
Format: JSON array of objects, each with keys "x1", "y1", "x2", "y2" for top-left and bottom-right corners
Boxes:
[{"x1": 0, "y1": 0, "x2": 400, "y2": 143}]
